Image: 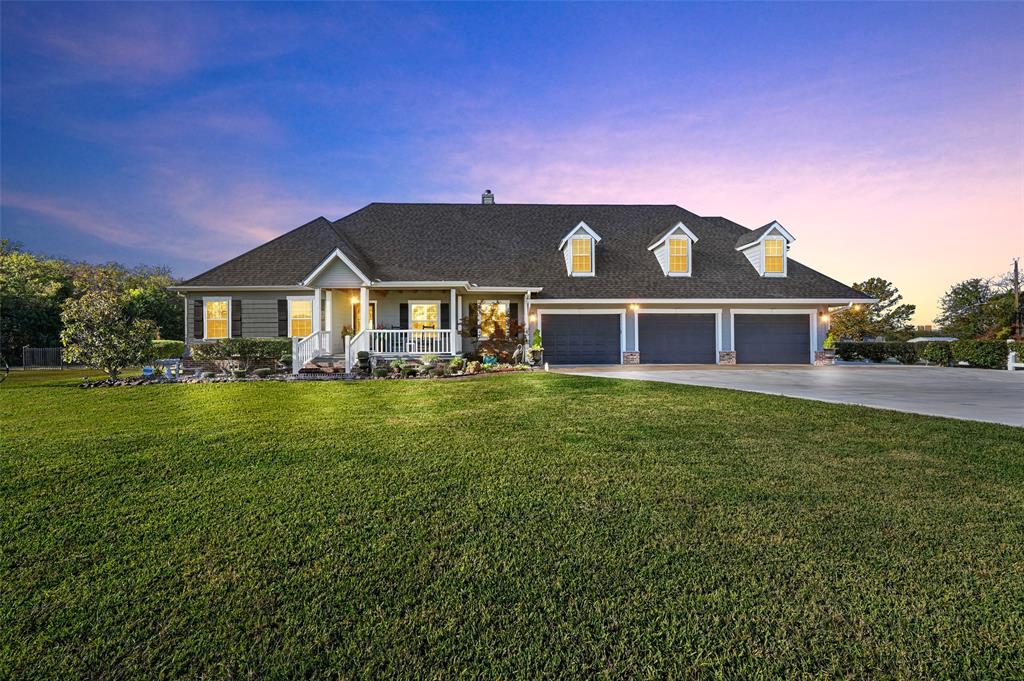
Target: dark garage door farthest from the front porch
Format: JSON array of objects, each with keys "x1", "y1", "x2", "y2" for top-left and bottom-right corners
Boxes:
[{"x1": 733, "y1": 314, "x2": 811, "y2": 365}]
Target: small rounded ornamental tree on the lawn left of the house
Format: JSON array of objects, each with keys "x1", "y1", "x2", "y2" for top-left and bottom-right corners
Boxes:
[{"x1": 60, "y1": 289, "x2": 157, "y2": 379}]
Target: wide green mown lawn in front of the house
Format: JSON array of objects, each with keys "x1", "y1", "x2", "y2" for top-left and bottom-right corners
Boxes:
[{"x1": 6, "y1": 371, "x2": 1024, "y2": 679}]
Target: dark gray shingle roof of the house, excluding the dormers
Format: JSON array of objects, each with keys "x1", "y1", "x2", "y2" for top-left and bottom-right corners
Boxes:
[{"x1": 184, "y1": 204, "x2": 866, "y2": 299}]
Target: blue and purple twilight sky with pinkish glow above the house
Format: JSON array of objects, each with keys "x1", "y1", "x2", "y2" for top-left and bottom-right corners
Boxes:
[{"x1": 0, "y1": 2, "x2": 1024, "y2": 322}]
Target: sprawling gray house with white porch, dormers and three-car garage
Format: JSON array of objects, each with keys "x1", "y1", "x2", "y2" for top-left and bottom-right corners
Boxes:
[{"x1": 173, "y1": 191, "x2": 874, "y2": 369}]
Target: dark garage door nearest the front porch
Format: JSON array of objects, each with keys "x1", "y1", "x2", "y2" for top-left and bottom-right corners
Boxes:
[{"x1": 541, "y1": 314, "x2": 622, "y2": 365}]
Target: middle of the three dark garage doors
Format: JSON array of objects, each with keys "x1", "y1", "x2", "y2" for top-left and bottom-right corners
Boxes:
[{"x1": 637, "y1": 312, "x2": 718, "y2": 365}]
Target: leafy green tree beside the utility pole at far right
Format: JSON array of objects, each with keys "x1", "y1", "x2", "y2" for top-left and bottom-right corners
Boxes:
[{"x1": 936, "y1": 278, "x2": 1014, "y2": 339}]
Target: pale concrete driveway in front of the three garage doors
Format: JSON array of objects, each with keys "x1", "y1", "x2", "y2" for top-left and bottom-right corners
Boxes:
[{"x1": 552, "y1": 365, "x2": 1024, "y2": 426}]
